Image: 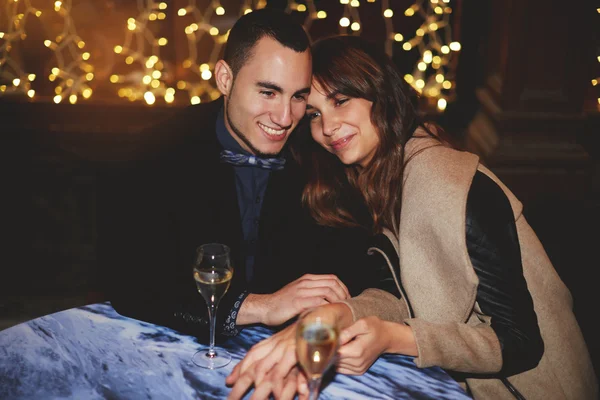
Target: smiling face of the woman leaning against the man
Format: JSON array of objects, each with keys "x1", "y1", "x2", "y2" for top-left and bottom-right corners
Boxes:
[{"x1": 306, "y1": 80, "x2": 379, "y2": 168}]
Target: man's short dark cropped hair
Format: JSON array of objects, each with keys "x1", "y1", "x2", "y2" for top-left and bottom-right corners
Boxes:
[{"x1": 223, "y1": 8, "x2": 310, "y2": 76}]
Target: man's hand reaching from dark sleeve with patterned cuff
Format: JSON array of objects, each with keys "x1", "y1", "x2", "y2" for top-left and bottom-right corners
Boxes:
[{"x1": 237, "y1": 274, "x2": 350, "y2": 326}]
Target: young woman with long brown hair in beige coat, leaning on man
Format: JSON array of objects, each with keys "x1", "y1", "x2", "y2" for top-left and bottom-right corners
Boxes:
[{"x1": 228, "y1": 36, "x2": 598, "y2": 399}]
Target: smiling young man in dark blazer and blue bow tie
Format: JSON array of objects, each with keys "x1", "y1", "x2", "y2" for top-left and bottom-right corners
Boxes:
[{"x1": 98, "y1": 9, "x2": 370, "y2": 336}]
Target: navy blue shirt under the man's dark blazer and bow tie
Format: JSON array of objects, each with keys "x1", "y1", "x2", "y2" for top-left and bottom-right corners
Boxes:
[{"x1": 216, "y1": 108, "x2": 271, "y2": 282}]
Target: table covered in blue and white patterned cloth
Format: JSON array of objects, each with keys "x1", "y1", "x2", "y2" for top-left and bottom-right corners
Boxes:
[{"x1": 0, "y1": 303, "x2": 469, "y2": 400}]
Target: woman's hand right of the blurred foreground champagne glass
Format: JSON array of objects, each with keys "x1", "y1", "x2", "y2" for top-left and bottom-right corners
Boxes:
[{"x1": 337, "y1": 317, "x2": 417, "y2": 375}]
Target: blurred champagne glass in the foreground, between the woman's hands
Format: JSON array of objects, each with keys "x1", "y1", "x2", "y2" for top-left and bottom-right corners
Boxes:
[{"x1": 296, "y1": 313, "x2": 339, "y2": 400}]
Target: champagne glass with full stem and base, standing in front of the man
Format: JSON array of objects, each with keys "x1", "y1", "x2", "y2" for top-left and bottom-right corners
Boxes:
[{"x1": 192, "y1": 243, "x2": 233, "y2": 369}]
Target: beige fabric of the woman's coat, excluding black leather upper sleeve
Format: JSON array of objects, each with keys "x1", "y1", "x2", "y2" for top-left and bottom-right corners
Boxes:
[{"x1": 347, "y1": 138, "x2": 598, "y2": 400}]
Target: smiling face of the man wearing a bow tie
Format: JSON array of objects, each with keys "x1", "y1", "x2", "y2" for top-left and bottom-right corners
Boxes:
[{"x1": 225, "y1": 37, "x2": 311, "y2": 157}]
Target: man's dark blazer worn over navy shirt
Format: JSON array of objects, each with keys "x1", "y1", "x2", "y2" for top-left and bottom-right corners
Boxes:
[{"x1": 98, "y1": 100, "x2": 370, "y2": 336}]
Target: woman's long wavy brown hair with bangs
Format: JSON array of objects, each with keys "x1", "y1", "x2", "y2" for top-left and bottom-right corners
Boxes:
[{"x1": 292, "y1": 36, "x2": 431, "y2": 233}]
